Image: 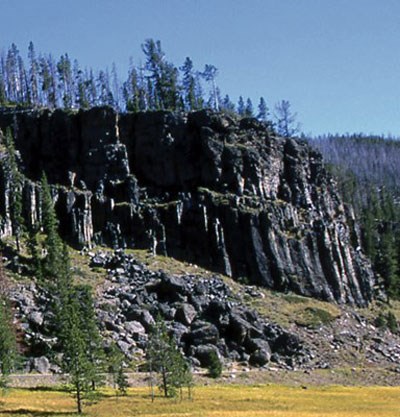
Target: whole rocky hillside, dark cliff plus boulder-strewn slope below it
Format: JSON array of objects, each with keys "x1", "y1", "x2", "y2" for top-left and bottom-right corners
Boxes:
[{"x1": 0, "y1": 107, "x2": 400, "y2": 372}]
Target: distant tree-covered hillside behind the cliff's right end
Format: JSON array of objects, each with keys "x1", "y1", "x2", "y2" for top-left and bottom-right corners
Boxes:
[{"x1": 310, "y1": 134, "x2": 400, "y2": 297}]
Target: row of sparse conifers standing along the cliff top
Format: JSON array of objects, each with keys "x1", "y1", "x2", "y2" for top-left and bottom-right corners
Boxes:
[{"x1": 0, "y1": 39, "x2": 287, "y2": 125}]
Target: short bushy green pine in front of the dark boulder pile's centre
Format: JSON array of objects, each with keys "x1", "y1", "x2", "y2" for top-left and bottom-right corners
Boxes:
[{"x1": 146, "y1": 318, "x2": 192, "y2": 397}]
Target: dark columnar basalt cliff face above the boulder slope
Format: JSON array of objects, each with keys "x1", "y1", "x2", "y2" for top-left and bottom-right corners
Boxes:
[{"x1": 0, "y1": 108, "x2": 374, "y2": 305}]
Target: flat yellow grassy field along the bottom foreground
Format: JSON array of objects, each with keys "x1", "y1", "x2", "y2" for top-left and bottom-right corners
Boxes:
[{"x1": 0, "y1": 385, "x2": 400, "y2": 417}]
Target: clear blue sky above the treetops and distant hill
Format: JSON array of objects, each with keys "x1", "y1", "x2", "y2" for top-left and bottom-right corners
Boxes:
[{"x1": 0, "y1": 0, "x2": 400, "y2": 136}]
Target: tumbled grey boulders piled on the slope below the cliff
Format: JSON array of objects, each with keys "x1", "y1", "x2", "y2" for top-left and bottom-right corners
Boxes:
[{"x1": 11, "y1": 250, "x2": 312, "y2": 373}]
